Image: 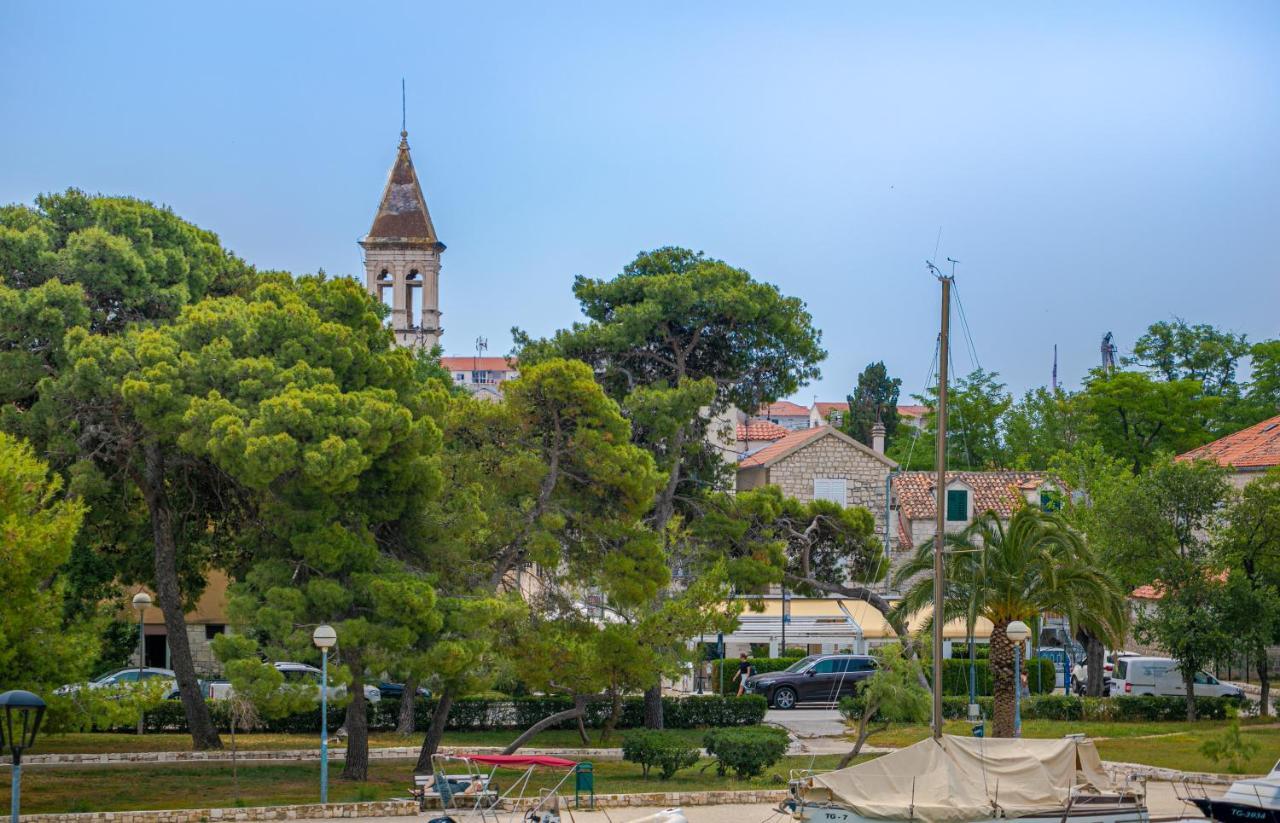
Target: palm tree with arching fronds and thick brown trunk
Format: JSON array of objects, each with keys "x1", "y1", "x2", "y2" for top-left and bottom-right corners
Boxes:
[{"x1": 893, "y1": 506, "x2": 1128, "y2": 737}]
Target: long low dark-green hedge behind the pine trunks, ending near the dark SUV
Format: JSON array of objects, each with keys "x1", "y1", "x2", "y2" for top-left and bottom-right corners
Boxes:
[{"x1": 132, "y1": 695, "x2": 768, "y2": 735}]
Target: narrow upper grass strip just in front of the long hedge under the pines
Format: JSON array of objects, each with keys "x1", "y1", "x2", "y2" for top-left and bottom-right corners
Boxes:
[{"x1": 31, "y1": 728, "x2": 703, "y2": 754}]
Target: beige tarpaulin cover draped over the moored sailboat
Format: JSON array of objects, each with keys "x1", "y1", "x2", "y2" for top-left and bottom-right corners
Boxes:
[{"x1": 805, "y1": 735, "x2": 1114, "y2": 823}]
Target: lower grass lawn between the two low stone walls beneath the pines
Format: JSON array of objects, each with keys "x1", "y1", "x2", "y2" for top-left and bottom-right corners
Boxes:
[{"x1": 0, "y1": 755, "x2": 860, "y2": 814}]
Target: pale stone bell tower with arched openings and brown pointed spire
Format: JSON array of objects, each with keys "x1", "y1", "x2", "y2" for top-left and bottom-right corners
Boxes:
[{"x1": 360, "y1": 132, "x2": 444, "y2": 348}]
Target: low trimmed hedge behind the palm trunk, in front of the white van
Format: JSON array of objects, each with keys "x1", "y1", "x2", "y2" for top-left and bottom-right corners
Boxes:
[{"x1": 840, "y1": 695, "x2": 1242, "y2": 723}]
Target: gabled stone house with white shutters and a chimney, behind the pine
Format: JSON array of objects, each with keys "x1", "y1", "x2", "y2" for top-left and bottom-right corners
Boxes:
[{"x1": 737, "y1": 426, "x2": 897, "y2": 563}]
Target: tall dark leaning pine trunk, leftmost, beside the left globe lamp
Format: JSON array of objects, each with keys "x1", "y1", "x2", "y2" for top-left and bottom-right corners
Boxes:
[{"x1": 140, "y1": 440, "x2": 223, "y2": 751}]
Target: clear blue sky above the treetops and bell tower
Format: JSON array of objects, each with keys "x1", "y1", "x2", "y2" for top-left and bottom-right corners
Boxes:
[{"x1": 0, "y1": 0, "x2": 1280, "y2": 403}]
